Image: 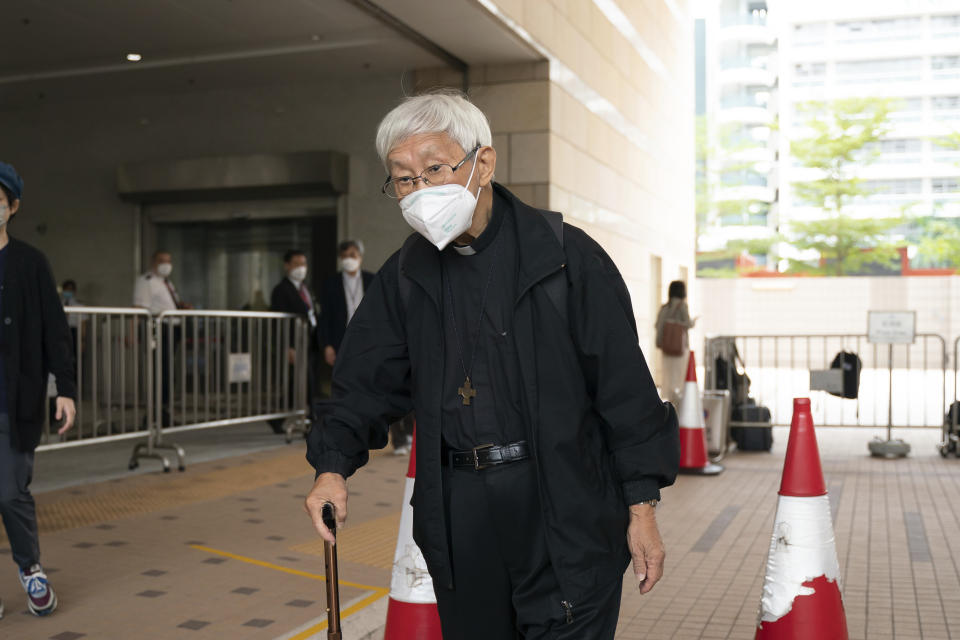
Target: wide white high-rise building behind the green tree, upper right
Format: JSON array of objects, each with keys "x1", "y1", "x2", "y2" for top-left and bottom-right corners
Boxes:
[{"x1": 771, "y1": 0, "x2": 960, "y2": 248}]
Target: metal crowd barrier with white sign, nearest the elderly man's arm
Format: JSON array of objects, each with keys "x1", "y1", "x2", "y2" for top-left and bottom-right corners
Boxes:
[{"x1": 142, "y1": 310, "x2": 309, "y2": 471}]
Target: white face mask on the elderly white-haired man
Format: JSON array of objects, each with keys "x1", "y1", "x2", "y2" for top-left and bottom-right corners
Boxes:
[{"x1": 400, "y1": 156, "x2": 483, "y2": 251}]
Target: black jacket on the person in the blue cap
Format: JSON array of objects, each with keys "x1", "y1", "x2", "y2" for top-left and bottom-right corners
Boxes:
[{"x1": 0, "y1": 238, "x2": 77, "y2": 451}]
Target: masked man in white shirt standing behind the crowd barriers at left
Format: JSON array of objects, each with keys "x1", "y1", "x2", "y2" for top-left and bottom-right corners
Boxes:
[{"x1": 128, "y1": 250, "x2": 193, "y2": 426}]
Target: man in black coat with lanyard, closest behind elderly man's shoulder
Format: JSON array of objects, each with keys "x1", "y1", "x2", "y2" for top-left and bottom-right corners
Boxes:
[{"x1": 320, "y1": 240, "x2": 374, "y2": 367}]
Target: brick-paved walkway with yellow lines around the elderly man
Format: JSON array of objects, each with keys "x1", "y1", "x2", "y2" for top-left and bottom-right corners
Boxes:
[{"x1": 0, "y1": 422, "x2": 944, "y2": 640}]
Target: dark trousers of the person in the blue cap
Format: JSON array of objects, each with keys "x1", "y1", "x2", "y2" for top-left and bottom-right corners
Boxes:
[{"x1": 0, "y1": 413, "x2": 40, "y2": 570}]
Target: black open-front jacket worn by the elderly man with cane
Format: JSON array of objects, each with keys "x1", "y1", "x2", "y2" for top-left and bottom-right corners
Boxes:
[{"x1": 307, "y1": 185, "x2": 680, "y2": 603}]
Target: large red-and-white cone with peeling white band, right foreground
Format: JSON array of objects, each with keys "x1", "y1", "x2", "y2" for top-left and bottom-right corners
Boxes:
[{"x1": 756, "y1": 398, "x2": 847, "y2": 640}]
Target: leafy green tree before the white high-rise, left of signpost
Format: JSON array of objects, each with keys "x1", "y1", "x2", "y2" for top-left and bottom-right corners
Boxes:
[{"x1": 790, "y1": 98, "x2": 904, "y2": 276}]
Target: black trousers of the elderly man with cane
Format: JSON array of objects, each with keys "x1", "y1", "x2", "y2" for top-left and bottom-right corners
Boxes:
[{"x1": 434, "y1": 460, "x2": 622, "y2": 640}]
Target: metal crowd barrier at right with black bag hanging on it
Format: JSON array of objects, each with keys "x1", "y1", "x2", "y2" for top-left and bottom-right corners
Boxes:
[{"x1": 704, "y1": 334, "x2": 948, "y2": 429}]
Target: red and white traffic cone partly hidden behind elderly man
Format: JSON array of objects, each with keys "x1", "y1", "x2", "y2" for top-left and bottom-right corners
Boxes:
[{"x1": 384, "y1": 428, "x2": 442, "y2": 640}]
